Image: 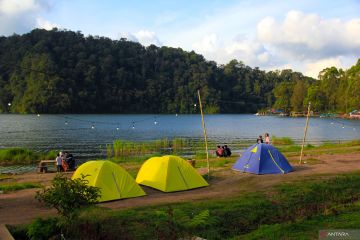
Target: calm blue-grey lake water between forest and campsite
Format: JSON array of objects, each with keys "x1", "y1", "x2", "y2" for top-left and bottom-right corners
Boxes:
[{"x1": 0, "y1": 114, "x2": 360, "y2": 172}]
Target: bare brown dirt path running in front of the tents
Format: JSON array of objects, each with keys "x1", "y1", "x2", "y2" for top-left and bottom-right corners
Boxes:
[{"x1": 0, "y1": 153, "x2": 360, "y2": 224}]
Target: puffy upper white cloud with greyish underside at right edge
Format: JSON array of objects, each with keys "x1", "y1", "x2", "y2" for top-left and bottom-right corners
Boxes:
[{"x1": 257, "y1": 11, "x2": 360, "y2": 60}]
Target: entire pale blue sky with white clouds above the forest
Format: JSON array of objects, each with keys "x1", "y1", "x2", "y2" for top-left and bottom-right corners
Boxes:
[{"x1": 0, "y1": 0, "x2": 360, "y2": 78}]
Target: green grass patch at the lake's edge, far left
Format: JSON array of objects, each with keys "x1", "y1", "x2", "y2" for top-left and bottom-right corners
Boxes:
[{"x1": 0, "y1": 148, "x2": 56, "y2": 166}]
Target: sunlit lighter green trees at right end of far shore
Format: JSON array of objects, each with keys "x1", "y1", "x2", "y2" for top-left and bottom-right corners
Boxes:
[{"x1": 273, "y1": 62, "x2": 360, "y2": 113}]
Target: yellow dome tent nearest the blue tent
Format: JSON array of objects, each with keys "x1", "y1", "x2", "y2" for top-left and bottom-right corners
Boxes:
[{"x1": 136, "y1": 155, "x2": 209, "y2": 192}]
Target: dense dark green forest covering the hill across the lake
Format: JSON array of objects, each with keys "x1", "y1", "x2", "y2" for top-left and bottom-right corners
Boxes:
[{"x1": 0, "y1": 29, "x2": 360, "y2": 113}]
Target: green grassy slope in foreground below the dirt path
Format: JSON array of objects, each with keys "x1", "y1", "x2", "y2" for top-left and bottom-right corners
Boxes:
[{"x1": 11, "y1": 173, "x2": 360, "y2": 239}]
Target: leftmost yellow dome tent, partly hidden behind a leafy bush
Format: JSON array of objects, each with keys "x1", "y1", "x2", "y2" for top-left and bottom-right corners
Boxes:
[{"x1": 72, "y1": 161, "x2": 146, "y2": 202}]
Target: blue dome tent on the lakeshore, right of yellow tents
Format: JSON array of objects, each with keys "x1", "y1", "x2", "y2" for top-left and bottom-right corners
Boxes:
[{"x1": 233, "y1": 143, "x2": 293, "y2": 174}]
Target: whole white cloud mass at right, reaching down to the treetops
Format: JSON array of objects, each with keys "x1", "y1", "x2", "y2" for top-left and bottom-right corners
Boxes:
[{"x1": 192, "y1": 11, "x2": 360, "y2": 78}]
